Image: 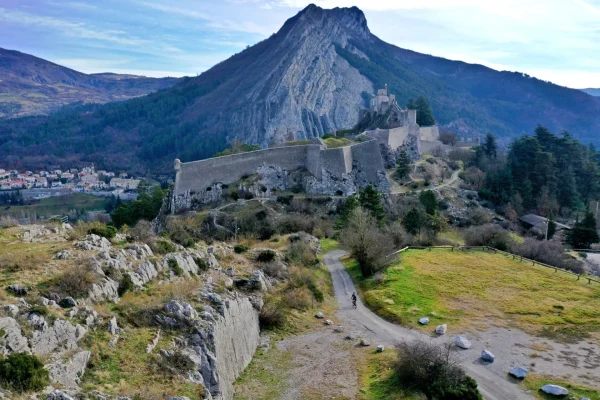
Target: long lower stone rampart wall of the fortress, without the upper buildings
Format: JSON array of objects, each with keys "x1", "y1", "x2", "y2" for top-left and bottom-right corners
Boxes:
[{"x1": 171, "y1": 140, "x2": 389, "y2": 212}]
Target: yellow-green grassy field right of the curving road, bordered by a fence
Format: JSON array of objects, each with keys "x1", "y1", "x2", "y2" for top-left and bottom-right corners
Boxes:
[{"x1": 344, "y1": 250, "x2": 600, "y2": 340}]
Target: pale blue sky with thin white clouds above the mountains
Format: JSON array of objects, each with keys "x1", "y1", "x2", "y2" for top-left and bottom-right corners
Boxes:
[{"x1": 0, "y1": 0, "x2": 600, "y2": 88}]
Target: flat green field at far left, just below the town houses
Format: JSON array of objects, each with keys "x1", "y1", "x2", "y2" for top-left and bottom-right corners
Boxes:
[{"x1": 0, "y1": 193, "x2": 108, "y2": 218}]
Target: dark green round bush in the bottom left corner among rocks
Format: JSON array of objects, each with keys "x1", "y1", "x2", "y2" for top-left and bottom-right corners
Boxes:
[{"x1": 0, "y1": 353, "x2": 50, "y2": 392}]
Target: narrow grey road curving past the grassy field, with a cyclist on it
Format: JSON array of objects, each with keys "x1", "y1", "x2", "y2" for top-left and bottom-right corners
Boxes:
[{"x1": 323, "y1": 250, "x2": 533, "y2": 400}]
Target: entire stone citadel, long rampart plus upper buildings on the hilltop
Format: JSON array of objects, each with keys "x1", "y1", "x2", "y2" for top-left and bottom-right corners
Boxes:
[{"x1": 170, "y1": 85, "x2": 440, "y2": 213}]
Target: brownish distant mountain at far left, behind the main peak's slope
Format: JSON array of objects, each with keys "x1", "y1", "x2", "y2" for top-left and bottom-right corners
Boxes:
[{"x1": 0, "y1": 48, "x2": 180, "y2": 118}]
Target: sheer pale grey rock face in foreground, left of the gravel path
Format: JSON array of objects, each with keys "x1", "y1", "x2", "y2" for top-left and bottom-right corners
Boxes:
[{"x1": 159, "y1": 297, "x2": 260, "y2": 400}]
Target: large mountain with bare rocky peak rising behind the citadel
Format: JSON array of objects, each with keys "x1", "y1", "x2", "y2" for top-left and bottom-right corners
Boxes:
[{"x1": 0, "y1": 5, "x2": 600, "y2": 174}]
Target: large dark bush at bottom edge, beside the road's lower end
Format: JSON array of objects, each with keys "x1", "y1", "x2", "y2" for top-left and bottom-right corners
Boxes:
[{"x1": 396, "y1": 341, "x2": 482, "y2": 400}]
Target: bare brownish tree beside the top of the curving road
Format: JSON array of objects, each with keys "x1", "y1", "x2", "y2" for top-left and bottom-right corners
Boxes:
[{"x1": 340, "y1": 208, "x2": 397, "y2": 277}]
